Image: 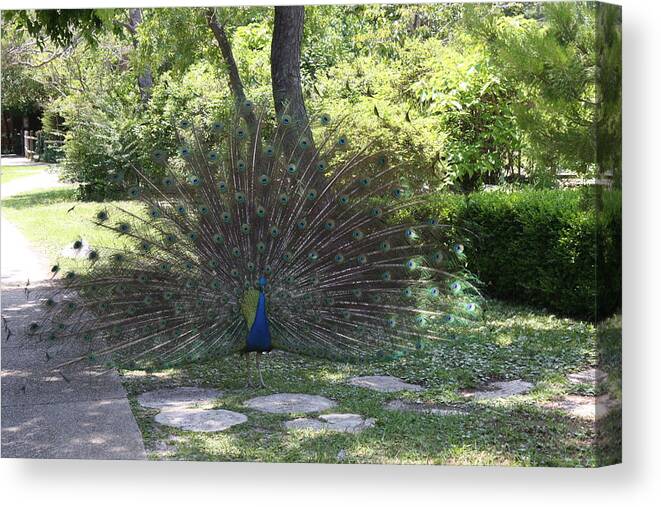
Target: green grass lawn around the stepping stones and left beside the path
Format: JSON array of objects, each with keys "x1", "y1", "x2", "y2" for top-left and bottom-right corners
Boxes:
[{"x1": 2, "y1": 185, "x2": 621, "y2": 467}]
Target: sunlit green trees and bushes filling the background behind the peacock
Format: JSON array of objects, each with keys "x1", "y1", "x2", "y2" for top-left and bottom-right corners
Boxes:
[{"x1": 3, "y1": 2, "x2": 621, "y2": 192}]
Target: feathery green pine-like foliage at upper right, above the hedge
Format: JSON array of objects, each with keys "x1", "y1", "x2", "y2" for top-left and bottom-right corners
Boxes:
[{"x1": 466, "y1": 2, "x2": 604, "y2": 181}]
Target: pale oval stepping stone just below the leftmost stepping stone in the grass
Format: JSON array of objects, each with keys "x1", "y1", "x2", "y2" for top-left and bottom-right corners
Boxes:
[{"x1": 154, "y1": 407, "x2": 248, "y2": 433}]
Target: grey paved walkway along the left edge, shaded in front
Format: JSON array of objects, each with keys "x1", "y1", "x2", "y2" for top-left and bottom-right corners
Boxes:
[{"x1": 0, "y1": 175, "x2": 146, "y2": 459}]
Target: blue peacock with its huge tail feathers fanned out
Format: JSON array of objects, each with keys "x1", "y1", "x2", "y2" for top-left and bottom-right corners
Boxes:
[{"x1": 28, "y1": 101, "x2": 479, "y2": 386}]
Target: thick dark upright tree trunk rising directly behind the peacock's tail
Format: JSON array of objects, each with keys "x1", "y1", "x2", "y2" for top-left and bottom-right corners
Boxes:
[{"x1": 271, "y1": 6, "x2": 314, "y2": 162}]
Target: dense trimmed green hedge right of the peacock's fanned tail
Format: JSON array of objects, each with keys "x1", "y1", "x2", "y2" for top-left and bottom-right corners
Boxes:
[{"x1": 409, "y1": 188, "x2": 622, "y2": 319}]
